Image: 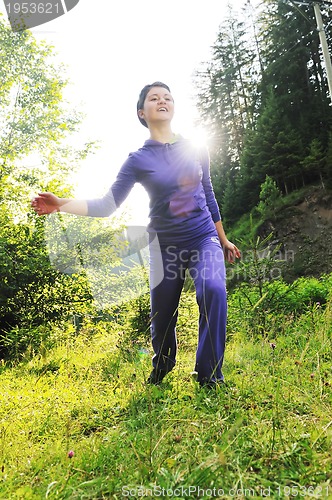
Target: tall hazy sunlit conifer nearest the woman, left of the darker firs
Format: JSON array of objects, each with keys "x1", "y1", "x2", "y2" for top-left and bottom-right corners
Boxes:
[{"x1": 196, "y1": 2, "x2": 259, "y2": 221}]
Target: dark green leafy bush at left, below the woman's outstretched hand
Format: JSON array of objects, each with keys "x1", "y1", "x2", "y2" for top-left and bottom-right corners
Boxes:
[{"x1": 0, "y1": 216, "x2": 92, "y2": 355}]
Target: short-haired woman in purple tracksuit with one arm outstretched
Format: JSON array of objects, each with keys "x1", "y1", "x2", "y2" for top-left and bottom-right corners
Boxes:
[{"x1": 32, "y1": 82, "x2": 240, "y2": 386}]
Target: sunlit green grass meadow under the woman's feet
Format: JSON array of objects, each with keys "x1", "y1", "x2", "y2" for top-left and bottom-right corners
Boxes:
[{"x1": 0, "y1": 297, "x2": 332, "y2": 500}]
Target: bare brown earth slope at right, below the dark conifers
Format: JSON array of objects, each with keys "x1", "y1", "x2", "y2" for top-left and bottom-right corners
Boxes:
[{"x1": 259, "y1": 186, "x2": 332, "y2": 280}]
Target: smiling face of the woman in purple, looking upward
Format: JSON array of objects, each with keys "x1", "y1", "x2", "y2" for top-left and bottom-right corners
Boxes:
[{"x1": 139, "y1": 87, "x2": 174, "y2": 126}]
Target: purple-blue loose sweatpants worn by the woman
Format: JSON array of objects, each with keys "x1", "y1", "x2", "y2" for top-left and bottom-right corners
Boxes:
[{"x1": 150, "y1": 235, "x2": 227, "y2": 384}]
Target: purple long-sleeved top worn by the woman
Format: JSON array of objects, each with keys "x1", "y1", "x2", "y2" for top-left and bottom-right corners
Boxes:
[{"x1": 88, "y1": 138, "x2": 220, "y2": 244}]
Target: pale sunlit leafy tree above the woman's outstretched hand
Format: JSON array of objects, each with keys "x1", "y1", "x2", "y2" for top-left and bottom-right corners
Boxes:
[{"x1": 0, "y1": 19, "x2": 95, "y2": 222}]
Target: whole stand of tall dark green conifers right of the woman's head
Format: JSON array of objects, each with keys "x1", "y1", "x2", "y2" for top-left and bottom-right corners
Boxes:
[{"x1": 198, "y1": 0, "x2": 332, "y2": 222}]
